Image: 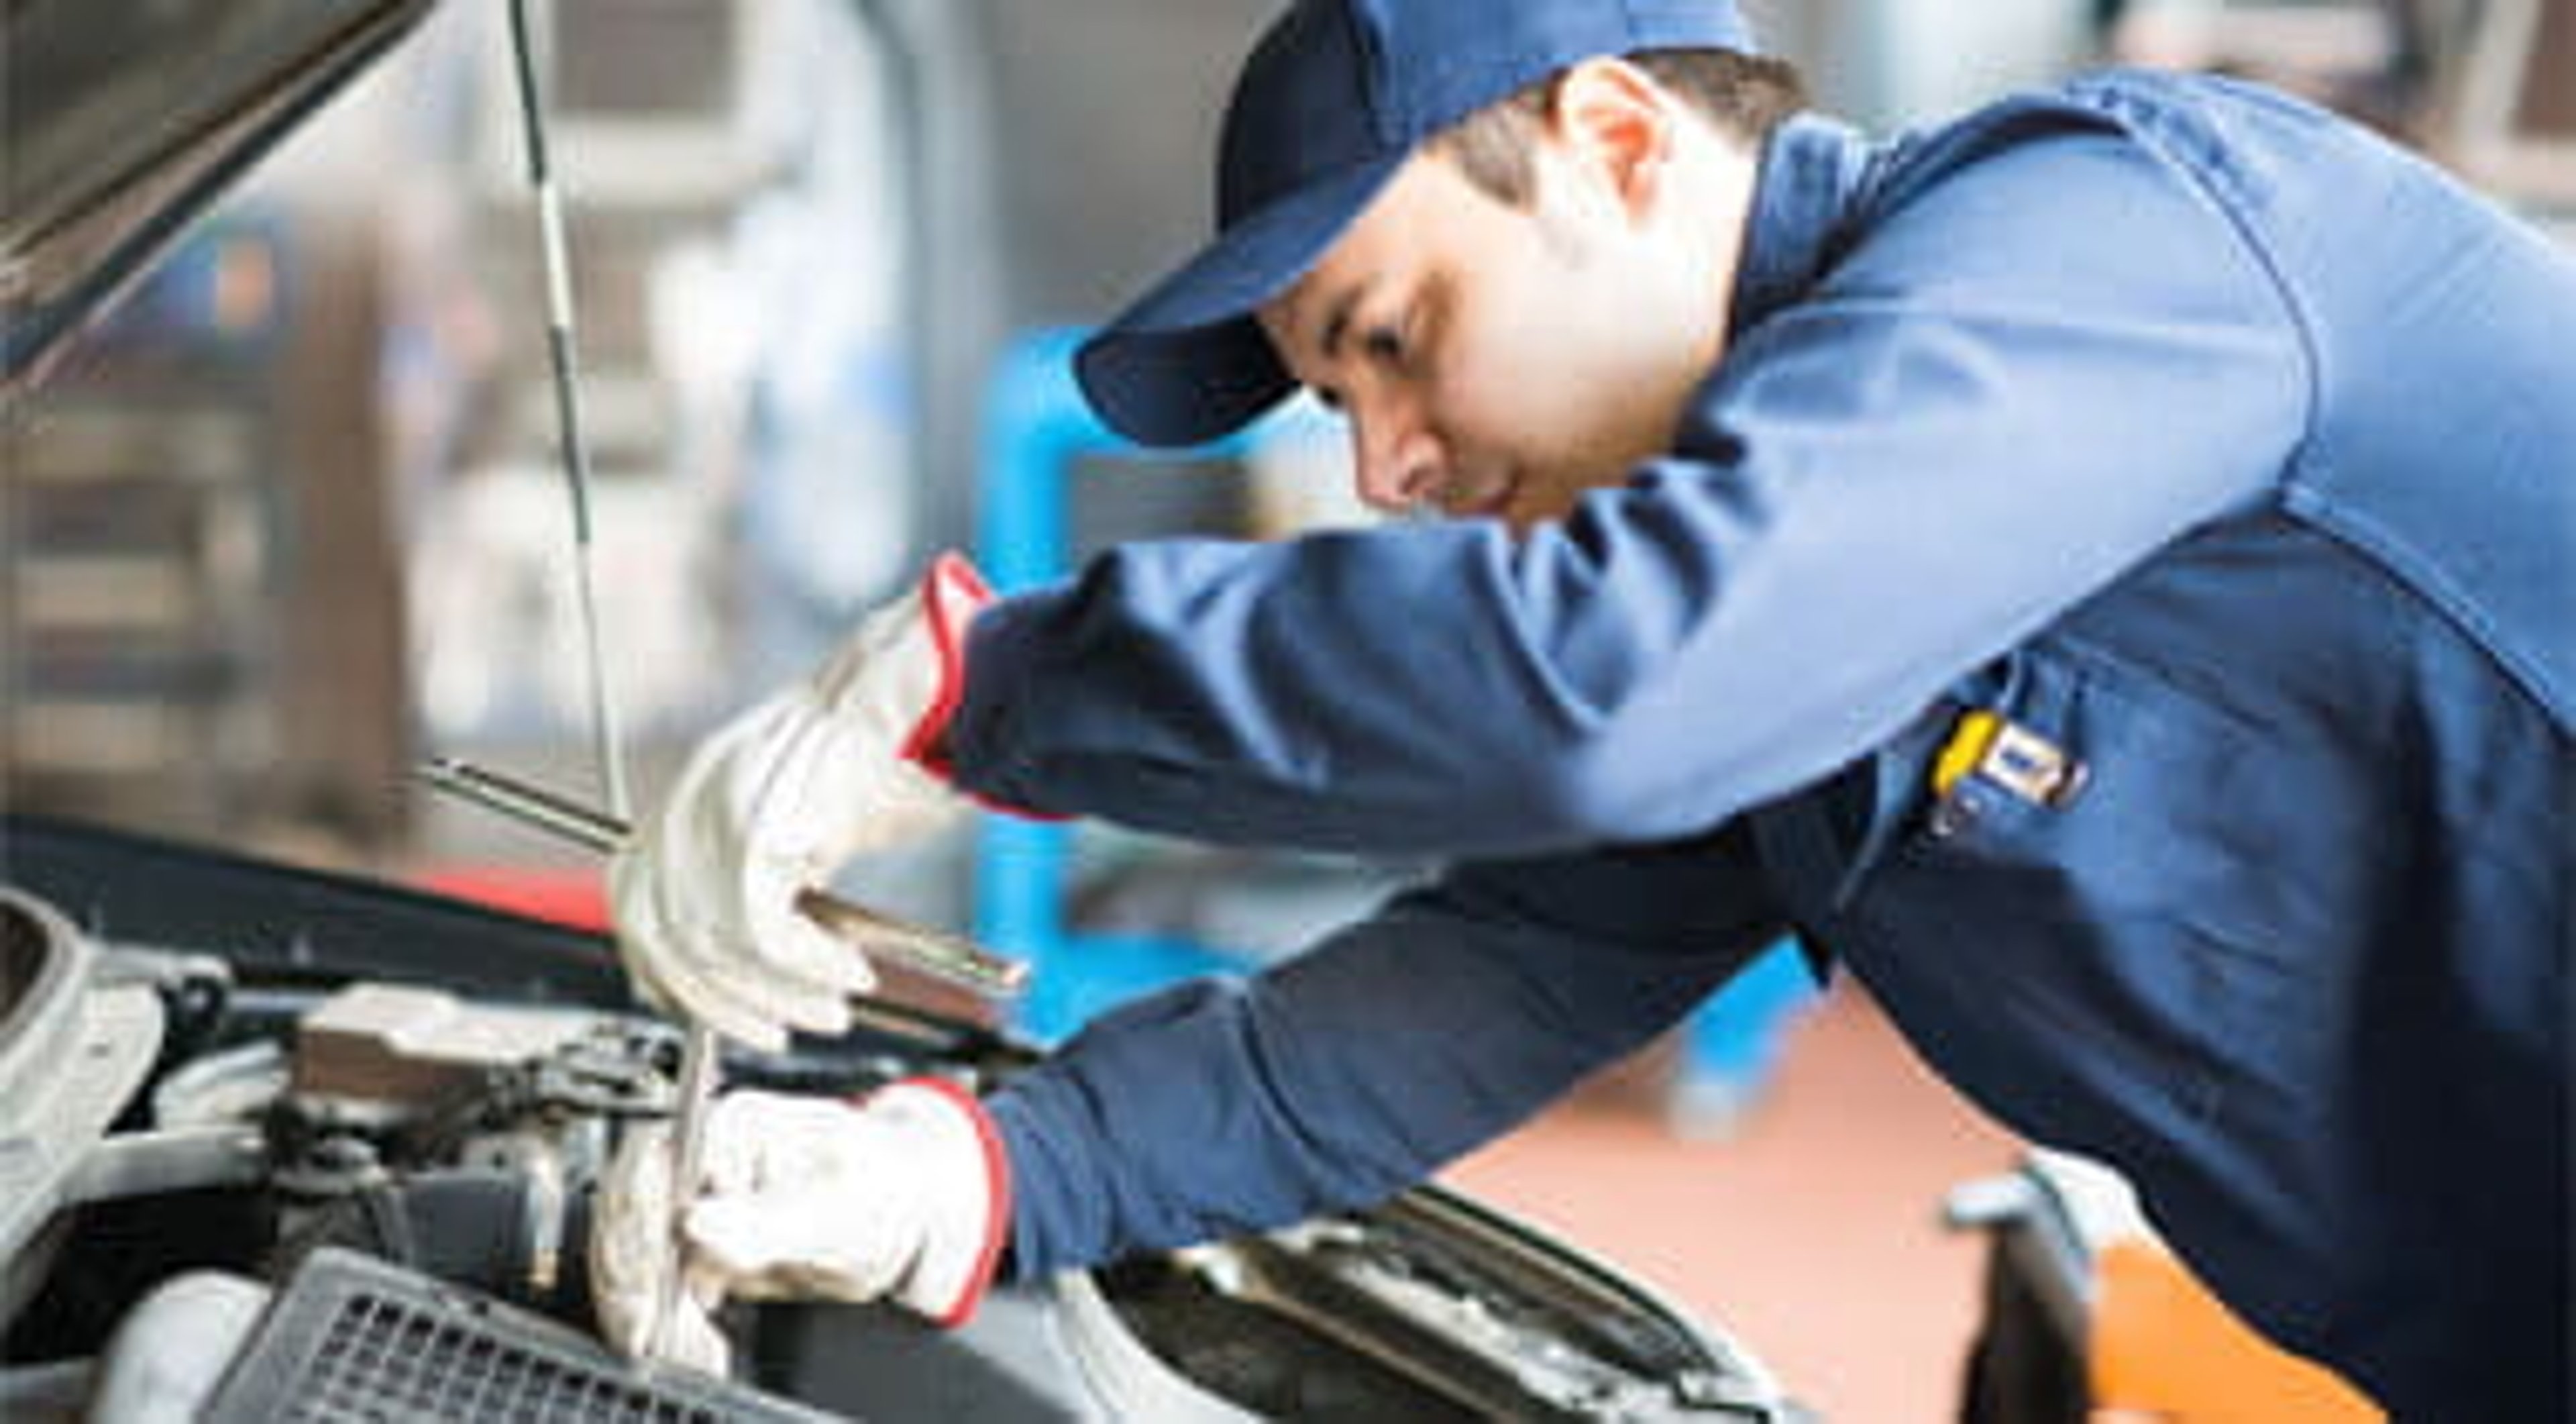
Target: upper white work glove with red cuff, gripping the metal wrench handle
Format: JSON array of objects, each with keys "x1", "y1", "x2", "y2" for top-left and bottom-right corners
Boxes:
[{"x1": 608, "y1": 554, "x2": 991, "y2": 1051}]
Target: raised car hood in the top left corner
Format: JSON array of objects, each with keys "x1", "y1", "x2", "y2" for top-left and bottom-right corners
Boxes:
[{"x1": 0, "y1": 0, "x2": 430, "y2": 397}]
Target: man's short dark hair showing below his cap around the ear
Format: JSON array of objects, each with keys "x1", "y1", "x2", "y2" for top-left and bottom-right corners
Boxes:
[{"x1": 1432, "y1": 49, "x2": 1806, "y2": 209}]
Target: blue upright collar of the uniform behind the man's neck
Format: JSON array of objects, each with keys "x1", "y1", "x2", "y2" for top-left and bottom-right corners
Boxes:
[{"x1": 1729, "y1": 113, "x2": 1870, "y2": 335}]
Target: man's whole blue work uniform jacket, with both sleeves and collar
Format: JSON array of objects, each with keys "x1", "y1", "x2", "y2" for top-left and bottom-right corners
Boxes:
[{"x1": 953, "y1": 74, "x2": 2576, "y2": 1421}]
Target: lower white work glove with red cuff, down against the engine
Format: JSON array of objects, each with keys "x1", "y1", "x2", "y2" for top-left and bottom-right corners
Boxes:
[{"x1": 590, "y1": 1079, "x2": 1010, "y2": 1372}]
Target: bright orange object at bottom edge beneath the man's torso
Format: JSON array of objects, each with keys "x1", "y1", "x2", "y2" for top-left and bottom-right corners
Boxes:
[{"x1": 2089, "y1": 1241, "x2": 2388, "y2": 1424}]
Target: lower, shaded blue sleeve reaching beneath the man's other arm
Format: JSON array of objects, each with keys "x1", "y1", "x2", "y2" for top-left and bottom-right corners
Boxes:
[{"x1": 991, "y1": 829, "x2": 1780, "y2": 1277}]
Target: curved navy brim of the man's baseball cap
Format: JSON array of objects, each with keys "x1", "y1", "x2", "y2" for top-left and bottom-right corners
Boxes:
[{"x1": 1074, "y1": 154, "x2": 1404, "y2": 446}]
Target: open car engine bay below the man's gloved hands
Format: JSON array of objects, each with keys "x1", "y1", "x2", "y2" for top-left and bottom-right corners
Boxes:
[{"x1": 0, "y1": 816, "x2": 1793, "y2": 1421}]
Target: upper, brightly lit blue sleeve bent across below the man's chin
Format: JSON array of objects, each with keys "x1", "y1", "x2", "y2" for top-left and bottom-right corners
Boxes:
[{"x1": 951, "y1": 119, "x2": 2308, "y2": 858}]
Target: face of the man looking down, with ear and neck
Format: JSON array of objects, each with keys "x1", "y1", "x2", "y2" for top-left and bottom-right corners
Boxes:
[{"x1": 1260, "y1": 139, "x2": 1723, "y2": 530}]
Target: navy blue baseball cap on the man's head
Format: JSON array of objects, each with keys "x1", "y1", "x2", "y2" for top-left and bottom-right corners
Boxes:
[{"x1": 1074, "y1": 0, "x2": 1752, "y2": 446}]
